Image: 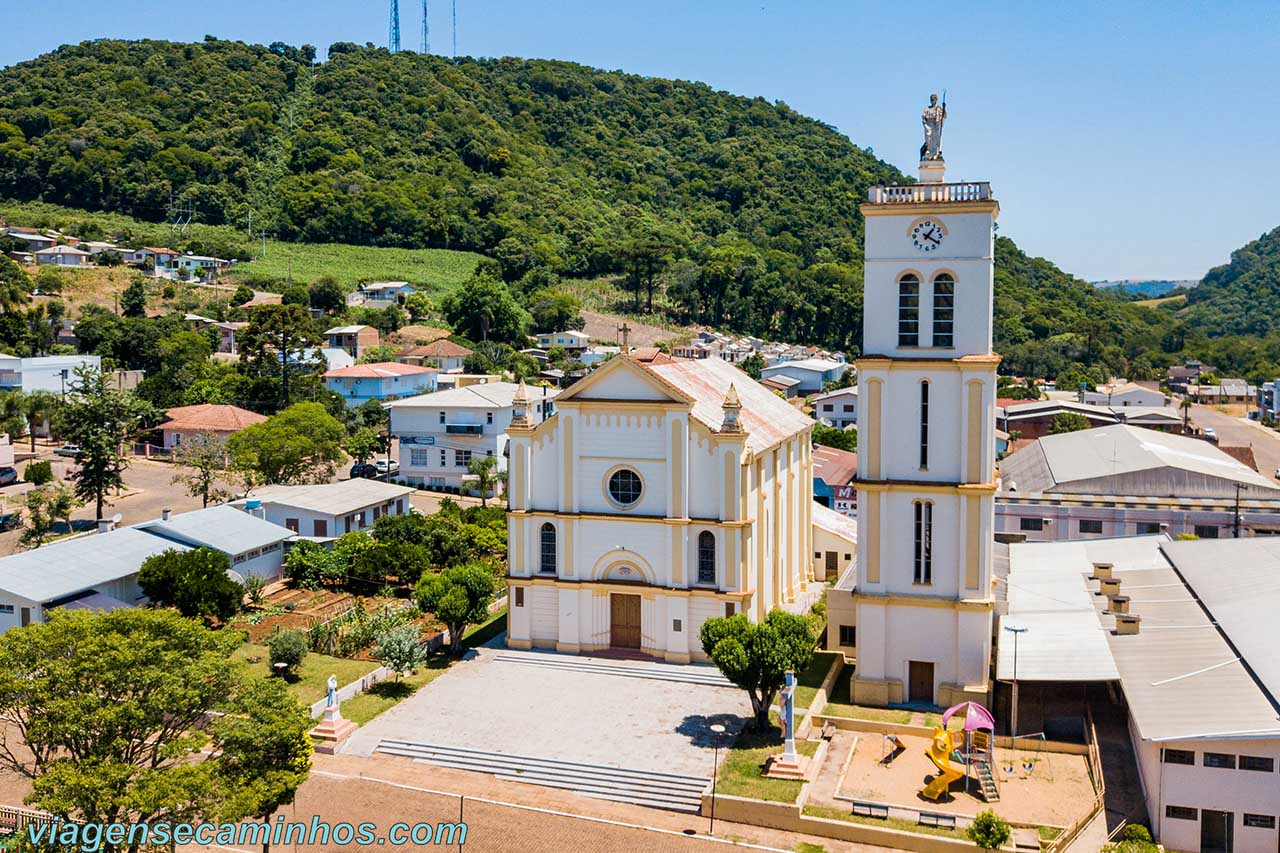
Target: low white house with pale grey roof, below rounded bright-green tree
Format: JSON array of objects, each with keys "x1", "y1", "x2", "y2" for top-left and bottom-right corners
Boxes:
[{"x1": 236, "y1": 478, "x2": 413, "y2": 539}]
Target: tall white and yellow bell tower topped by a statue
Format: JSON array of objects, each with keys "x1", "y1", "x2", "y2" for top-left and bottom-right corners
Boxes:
[{"x1": 852, "y1": 102, "x2": 1000, "y2": 706}]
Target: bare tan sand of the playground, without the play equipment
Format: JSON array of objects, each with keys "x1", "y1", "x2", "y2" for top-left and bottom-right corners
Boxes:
[{"x1": 815, "y1": 731, "x2": 1093, "y2": 826}]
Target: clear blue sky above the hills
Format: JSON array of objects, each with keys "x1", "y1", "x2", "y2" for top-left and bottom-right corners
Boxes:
[{"x1": 0, "y1": 0, "x2": 1280, "y2": 278}]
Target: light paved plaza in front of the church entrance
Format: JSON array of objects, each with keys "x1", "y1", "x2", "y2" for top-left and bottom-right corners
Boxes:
[{"x1": 343, "y1": 638, "x2": 750, "y2": 777}]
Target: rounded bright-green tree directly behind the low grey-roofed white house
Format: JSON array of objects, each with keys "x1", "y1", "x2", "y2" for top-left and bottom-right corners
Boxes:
[{"x1": 227, "y1": 403, "x2": 343, "y2": 487}]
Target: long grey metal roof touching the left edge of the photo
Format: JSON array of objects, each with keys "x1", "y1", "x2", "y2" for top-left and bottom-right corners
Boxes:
[{"x1": 0, "y1": 528, "x2": 191, "y2": 602}]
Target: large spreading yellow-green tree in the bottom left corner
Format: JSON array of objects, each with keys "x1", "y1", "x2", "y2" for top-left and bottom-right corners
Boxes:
[{"x1": 0, "y1": 608, "x2": 312, "y2": 824}]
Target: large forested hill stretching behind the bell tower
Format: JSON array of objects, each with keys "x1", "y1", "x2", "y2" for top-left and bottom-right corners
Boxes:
[{"x1": 0, "y1": 38, "x2": 1180, "y2": 378}]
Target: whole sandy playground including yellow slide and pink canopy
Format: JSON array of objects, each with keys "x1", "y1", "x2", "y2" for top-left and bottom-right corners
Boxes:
[{"x1": 815, "y1": 703, "x2": 1096, "y2": 826}]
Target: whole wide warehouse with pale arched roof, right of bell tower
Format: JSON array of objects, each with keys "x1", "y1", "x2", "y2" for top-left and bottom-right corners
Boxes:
[{"x1": 995, "y1": 424, "x2": 1280, "y2": 540}]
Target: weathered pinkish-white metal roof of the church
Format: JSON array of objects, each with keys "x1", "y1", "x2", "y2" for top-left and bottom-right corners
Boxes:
[{"x1": 645, "y1": 359, "x2": 814, "y2": 452}]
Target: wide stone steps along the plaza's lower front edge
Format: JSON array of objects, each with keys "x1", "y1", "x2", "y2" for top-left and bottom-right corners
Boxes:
[{"x1": 375, "y1": 740, "x2": 710, "y2": 813}]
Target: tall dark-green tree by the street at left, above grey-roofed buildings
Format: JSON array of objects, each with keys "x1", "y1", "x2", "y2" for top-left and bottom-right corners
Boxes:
[{"x1": 58, "y1": 366, "x2": 157, "y2": 519}]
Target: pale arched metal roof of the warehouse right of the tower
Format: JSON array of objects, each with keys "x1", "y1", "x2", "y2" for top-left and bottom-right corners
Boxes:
[{"x1": 1001, "y1": 424, "x2": 1280, "y2": 497}]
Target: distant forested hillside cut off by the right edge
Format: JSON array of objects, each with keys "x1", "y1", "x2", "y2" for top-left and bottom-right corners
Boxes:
[{"x1": 1185, "y1": 228, "x2": 1280, "y2": 336}]
